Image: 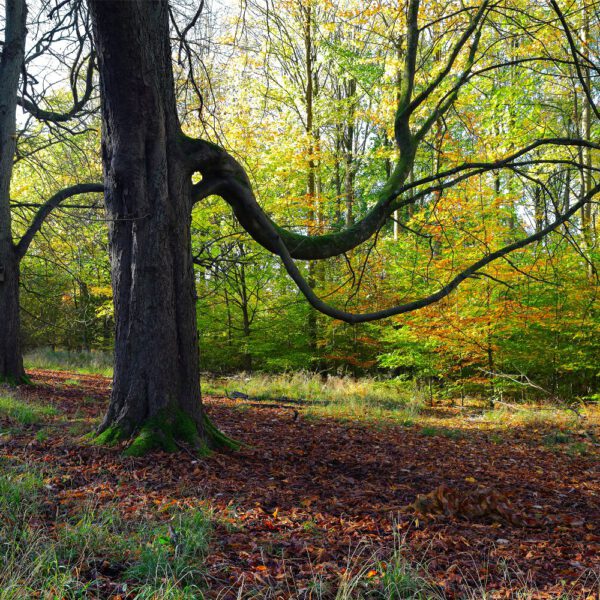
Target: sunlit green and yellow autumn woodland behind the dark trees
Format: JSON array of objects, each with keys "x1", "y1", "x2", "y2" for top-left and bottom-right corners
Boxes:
[{"x1": 12, "y1": 0, "x2": 600, "y2": 401}]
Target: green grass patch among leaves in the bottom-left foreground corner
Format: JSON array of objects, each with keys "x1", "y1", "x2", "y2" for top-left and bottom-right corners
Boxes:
[{"x1": 0, "y1": 460, "x2": 212, "y2": 600}]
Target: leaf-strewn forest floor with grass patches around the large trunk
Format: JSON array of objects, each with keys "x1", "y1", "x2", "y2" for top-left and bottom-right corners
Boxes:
[{"x1": 0, "y1": 370, "x2": 600, "y2": 600}]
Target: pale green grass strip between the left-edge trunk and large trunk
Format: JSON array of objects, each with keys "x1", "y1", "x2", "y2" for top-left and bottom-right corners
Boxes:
[{"x1": 23, "y1": 348, "x2": 113, "y2": 376}]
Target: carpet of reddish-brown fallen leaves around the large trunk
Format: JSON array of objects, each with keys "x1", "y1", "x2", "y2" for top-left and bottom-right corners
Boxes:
[{"x1": 1, "y1": 371, "x2": 600, "y2": 599}]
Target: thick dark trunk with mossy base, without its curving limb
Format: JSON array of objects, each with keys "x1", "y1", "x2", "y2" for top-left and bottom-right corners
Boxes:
[{"x1": 90, "y1": 0, "x2": 233, "y2": 454}]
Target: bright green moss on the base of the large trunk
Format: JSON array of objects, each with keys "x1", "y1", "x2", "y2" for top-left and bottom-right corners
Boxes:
[{"x1": 94, "y1": 409, "x2": 242, "y2": 456}]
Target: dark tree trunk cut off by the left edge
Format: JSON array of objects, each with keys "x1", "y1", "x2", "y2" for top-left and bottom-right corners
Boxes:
[{"x1": 0, "y1": 0, "x2": 27, "y2": 383}]
